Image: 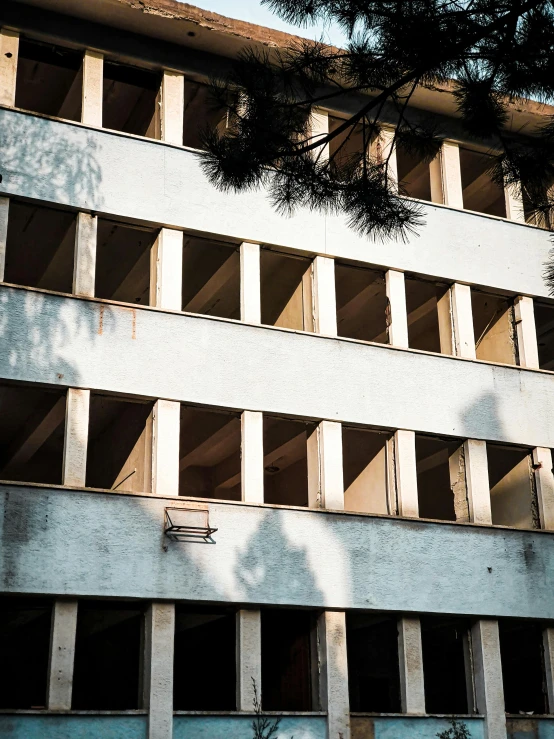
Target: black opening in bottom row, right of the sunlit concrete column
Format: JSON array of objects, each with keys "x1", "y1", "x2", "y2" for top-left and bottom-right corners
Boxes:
[{"x1": 346, "y1": 612, "x2": 402, "y2": 713}]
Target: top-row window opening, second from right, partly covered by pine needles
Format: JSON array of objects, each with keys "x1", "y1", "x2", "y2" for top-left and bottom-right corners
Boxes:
[{"x1": 460, "y1": 147, "x2": 506, "y2": 218}]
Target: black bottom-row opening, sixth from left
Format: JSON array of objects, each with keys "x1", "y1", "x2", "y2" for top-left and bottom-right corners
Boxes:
[{"x1": 421, "y1": 616, "x2": 473, "y2": 715}]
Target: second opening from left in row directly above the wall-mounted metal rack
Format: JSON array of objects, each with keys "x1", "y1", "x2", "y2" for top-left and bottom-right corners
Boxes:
[{"x1": 86, "y1": 393, "x2": 154, "y2": 493}]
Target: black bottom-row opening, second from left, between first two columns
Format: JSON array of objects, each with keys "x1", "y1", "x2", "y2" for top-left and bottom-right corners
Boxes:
[{"x1": 71, "y1": 600, "x2": 144, "y2": 711}]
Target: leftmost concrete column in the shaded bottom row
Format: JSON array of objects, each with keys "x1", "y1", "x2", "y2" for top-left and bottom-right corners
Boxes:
[{"x1": 46, "y1": 600, "x2": 77, "y2": 711}]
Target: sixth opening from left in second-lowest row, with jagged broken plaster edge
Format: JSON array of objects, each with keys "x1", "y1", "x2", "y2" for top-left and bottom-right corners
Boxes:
[{"x1": 415, "y1": 434, "x2": 469, "y2": 522}]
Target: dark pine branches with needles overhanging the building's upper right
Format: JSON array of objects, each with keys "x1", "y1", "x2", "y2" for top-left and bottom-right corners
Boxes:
[{"x1": 202, "y1": 0, "x2": 554, "y2": 249}]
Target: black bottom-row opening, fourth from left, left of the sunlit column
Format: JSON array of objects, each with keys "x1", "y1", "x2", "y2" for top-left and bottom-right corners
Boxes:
[{"x1": 262, "y1": 608, "x2": 318, "y2": 711}]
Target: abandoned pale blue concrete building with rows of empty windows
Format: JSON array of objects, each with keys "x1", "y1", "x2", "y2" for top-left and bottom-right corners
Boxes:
[{"x1": 0, "y1": 0, "x2": 554, "y2": 739}]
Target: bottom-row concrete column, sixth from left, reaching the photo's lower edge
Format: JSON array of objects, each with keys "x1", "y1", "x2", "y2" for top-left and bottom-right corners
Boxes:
[{"x1": 471, "y1": 620, "x2": 506, "y2": 739}]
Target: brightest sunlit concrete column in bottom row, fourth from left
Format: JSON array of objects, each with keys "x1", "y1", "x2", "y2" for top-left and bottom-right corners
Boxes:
[{"x1": 317, "y1": 611, "x2": 350, "y2": 739}]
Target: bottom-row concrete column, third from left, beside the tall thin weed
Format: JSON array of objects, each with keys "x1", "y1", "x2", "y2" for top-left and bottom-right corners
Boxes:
[{"x1": 236, "y1": 610, "x2": 262, "y2": 711}]
